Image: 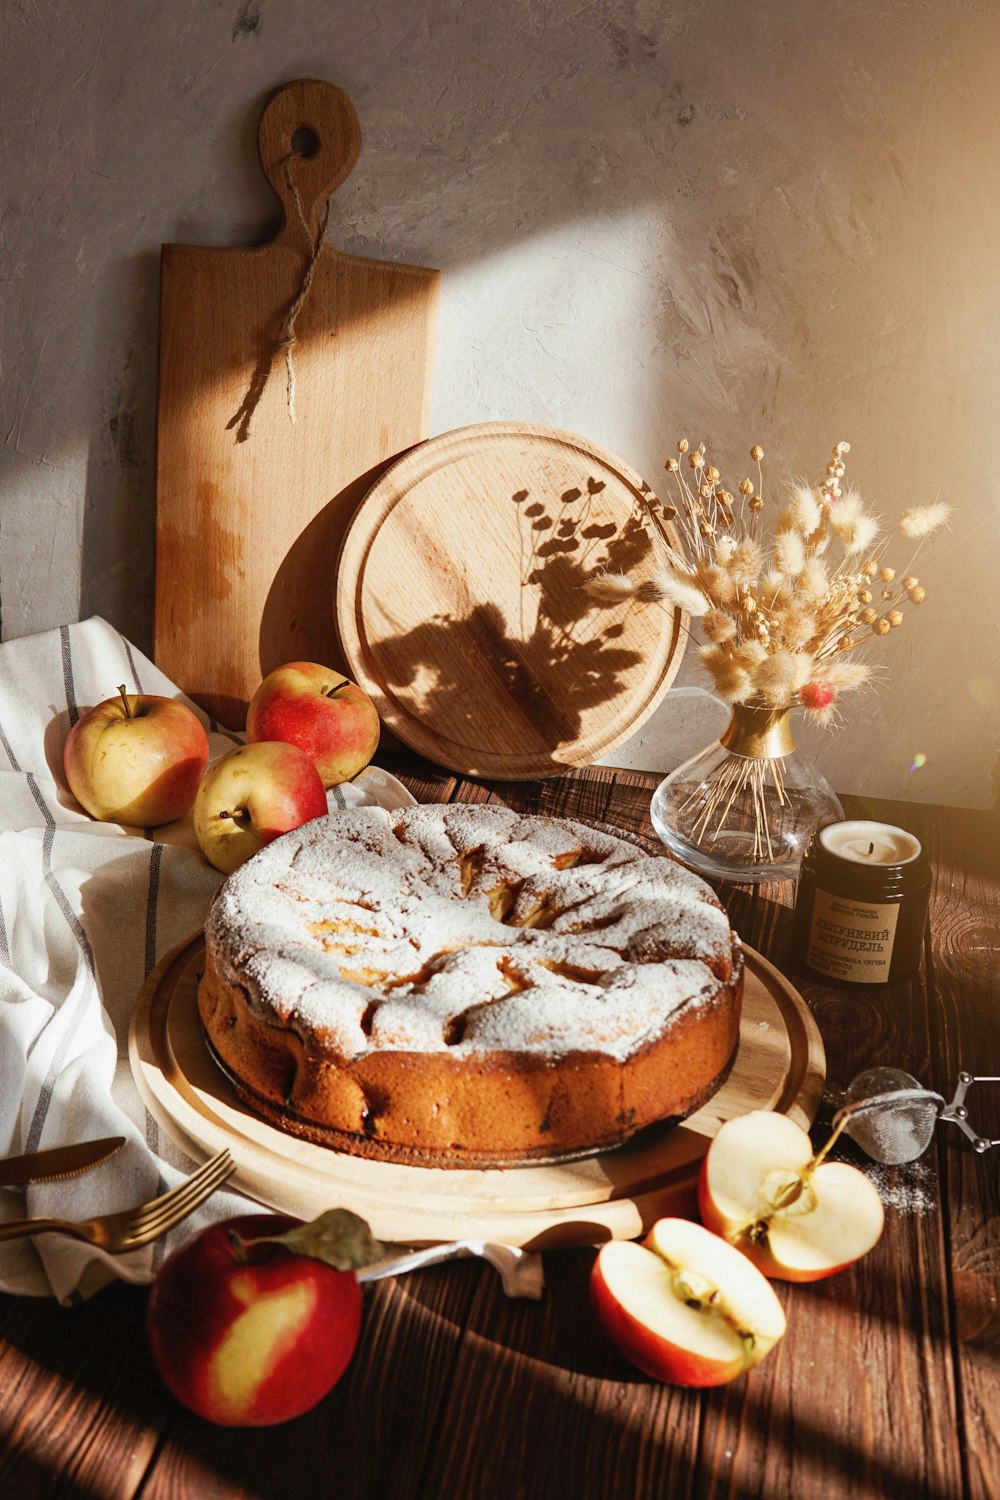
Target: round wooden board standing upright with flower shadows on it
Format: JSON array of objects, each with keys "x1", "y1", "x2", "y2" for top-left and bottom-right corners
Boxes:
[{"x1": 336, "y1": 422, "x2": 684, "y2": 780}]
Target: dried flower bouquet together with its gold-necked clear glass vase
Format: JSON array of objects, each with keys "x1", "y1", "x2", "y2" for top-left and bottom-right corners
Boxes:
[{"x1": 585, "y1": 438, "x2": 951, "y2": 878}]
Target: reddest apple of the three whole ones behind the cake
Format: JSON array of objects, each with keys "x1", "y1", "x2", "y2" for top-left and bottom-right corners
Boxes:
[{"x1": 246, "y1": 662, "x2": 379, "y2": 786}]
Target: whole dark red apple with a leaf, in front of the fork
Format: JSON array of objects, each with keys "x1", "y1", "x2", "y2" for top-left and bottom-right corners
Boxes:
[{"x1": 147, "y1": 1214, "x2": 361, "y2": 1427}]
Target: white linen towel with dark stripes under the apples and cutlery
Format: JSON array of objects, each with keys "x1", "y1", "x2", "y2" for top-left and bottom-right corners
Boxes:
[{"x1": 0, "y1": 618, "x2": 413, "y2": 1304}]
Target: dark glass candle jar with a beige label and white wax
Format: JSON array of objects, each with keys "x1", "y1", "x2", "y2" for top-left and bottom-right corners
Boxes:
[{"x1": 795, "y1": 819, "x2": 931, "y2": 984}]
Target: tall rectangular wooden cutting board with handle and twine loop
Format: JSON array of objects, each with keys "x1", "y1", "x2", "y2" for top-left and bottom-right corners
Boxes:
[{"x1": 154, "y1": 80, "x2": 439, "y2": 728}]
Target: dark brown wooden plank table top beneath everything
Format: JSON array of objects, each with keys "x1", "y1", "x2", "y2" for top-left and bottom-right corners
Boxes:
[{"x1": 0, "y1": 758, "x2": 1000, "y2": 1500}]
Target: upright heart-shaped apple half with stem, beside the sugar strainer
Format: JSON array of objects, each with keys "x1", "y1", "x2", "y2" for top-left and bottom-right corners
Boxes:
[{"x1": 699, "y1": 1110, "x2": 885, "y2": 1281}]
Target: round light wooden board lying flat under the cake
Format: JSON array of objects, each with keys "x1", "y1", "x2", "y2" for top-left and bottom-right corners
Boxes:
[{"x1": 129, "y1": 933, "x2": 826, "y2": 1248}]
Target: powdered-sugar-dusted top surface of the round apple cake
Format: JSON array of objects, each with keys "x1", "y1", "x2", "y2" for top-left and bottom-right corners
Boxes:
[{"x1": 207, "y1": 804, "x2": 736, "y2": 1061}]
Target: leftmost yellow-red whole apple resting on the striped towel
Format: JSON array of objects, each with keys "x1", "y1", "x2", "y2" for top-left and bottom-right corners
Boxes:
[{"x1": 63, "y1": 687, "x2": 208, "y2": 828}]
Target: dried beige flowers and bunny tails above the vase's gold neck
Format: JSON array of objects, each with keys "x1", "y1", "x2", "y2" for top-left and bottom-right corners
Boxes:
[{"x1": 585, "y1": 438, "x2": 951, "y2": 722}]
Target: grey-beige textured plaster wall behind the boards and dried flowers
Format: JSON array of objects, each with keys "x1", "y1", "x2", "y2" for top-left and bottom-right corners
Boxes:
[{"x1": 0, "y1": 0, "x2": 1000, "y2": 807}]
